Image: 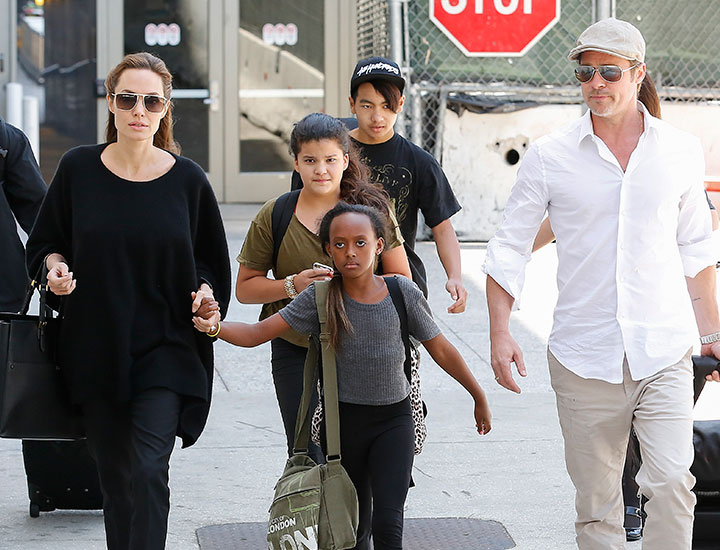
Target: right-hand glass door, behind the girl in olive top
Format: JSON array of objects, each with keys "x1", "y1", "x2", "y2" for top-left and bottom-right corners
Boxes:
[{"x1": 225, "y1": 0, "x2": 326, "y2": 202}]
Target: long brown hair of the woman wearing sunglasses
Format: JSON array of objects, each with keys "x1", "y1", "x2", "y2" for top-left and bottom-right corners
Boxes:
[{"x1": 105, "y1": 52, "x2": 180, "y2": 155}]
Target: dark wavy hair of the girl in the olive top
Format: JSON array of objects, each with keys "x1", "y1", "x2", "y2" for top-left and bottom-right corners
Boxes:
[{"x1": 290, "y1": 113, "x2": 390, "y2": 222}]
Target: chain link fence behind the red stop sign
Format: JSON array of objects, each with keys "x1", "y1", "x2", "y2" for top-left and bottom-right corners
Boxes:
[{"x1": 357, "y1": 0, "x2": 720, "y2": 158}]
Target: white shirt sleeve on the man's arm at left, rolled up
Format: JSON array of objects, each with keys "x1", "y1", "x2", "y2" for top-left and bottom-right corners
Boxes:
[{"x1": 482, "y1": 144, "x2": 548, "y2": 308}]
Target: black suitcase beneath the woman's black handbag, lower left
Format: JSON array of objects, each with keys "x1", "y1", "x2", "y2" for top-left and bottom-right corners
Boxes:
[{"x1": 22, "y1": 439, "x2": 102, "y2": 518}]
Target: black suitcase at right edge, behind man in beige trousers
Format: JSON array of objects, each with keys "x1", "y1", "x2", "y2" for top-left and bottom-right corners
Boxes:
[{"x1": 690, "y1": 355, "x2": 720, "y2": 550}]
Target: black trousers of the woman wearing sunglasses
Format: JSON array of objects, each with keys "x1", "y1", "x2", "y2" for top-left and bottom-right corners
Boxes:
[{"x1": 83, "y1": 388, "x2": 182, "y2": 550}]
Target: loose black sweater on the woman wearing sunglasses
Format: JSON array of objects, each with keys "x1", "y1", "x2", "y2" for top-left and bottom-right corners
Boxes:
[{"x1": 27, "y1": 144, "x2": 230, "y2": 446}]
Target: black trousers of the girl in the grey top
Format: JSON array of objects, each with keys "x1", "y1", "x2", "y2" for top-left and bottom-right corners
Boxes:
[{"x1": 323, "y1": 397, "x2": 415, "y2": 550}]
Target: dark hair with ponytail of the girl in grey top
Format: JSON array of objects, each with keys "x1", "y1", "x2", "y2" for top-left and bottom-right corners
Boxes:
[{"x1": 320, "y1": 205, "x2": 387, "y2": 349}]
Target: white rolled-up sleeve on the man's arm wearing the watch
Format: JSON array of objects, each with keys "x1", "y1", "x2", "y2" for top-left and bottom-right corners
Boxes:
[{"x1": 677, "y1": 141, "x2": 720, "y2": 277}]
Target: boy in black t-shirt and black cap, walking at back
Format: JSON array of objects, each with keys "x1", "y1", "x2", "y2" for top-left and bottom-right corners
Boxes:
[{"x1": 292, "y1": 57, "x2": 467, "y2": 313}]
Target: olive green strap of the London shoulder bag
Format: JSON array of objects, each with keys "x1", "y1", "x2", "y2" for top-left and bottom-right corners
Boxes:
[{"x1": 293, "y1": 281, "x2": 340, "y2": 462}]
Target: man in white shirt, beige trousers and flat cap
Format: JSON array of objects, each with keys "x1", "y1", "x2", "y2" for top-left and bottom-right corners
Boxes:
[{"x1": 483, "y1": 18, "x2": 720, "y2": 550}]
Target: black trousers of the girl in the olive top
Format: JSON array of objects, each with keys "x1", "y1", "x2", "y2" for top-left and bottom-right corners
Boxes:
[{"x1": 270, "y1": 338, "x2": 325, "y2": 464}]
